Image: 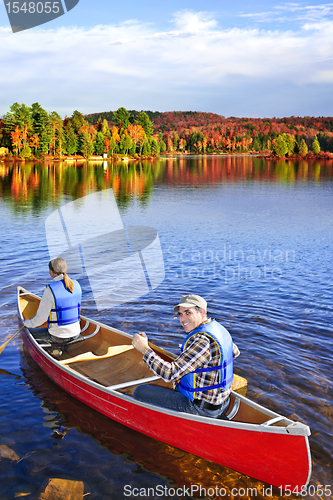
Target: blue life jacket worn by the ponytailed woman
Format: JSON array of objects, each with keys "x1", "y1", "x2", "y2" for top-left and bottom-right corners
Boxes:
[{"x1": 47, "y1": 280, "x2": 82, "y2": 327}]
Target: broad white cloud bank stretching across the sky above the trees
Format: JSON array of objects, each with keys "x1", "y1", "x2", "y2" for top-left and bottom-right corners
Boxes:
[{"x1": 0, "y1": 7, "x2": 333, "y2": 115}]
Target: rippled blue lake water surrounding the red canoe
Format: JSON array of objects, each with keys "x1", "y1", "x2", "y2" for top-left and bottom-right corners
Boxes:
[{"x1": 0, "y1": 156, "x2": 333, "y2": 500}]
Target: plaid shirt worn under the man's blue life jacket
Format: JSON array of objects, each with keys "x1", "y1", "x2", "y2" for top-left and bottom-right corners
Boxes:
[{"x1": 143, "y1": 320, "x2": 239, "y2": 405}]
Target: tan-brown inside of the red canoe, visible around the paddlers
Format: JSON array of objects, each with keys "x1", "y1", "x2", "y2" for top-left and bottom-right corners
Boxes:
[{"x1": 19, "y1": 289, "x2": 291, "y2": 426}]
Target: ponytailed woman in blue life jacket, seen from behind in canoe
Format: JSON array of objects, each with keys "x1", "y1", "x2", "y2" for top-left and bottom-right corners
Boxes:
[{"x1": 24, "y1": 257, "x2": 82, "y2": 344}]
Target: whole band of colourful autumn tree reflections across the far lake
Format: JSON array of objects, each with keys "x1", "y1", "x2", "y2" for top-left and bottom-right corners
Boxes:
[{"x1": 0, "y1": 156, "x2": 333, "y2": 212}]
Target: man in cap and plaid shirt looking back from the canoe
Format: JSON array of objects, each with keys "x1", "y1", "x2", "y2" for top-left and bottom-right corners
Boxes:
[{"x1": 132, "y1": 295, "x2": 239, "y2": 418}]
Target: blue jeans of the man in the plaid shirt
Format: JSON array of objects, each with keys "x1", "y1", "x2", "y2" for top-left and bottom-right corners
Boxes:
[{"x1": 134, "y1": 384, "x2": 230, "y2": 418}]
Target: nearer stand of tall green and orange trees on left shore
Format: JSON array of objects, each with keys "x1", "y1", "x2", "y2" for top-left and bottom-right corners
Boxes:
[{"x1": 0, "y1": 102, "x2": 160, "y2": 158}]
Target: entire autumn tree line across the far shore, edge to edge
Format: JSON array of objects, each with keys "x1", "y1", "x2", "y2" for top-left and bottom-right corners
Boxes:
[{"x1": 0, "y1": 103, "x2": 333, "y2": 158}]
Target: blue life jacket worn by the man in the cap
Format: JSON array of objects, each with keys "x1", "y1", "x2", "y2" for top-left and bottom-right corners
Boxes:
[{"x1": 178, "y1": 319, "x2": 234, "y2": 401}]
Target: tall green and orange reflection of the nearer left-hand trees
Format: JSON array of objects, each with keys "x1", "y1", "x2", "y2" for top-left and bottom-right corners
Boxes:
[{"x1": 0, "y1": 161, "x2": 159, "y2": 212}]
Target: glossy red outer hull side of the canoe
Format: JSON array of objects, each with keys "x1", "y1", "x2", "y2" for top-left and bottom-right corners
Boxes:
[{"x1": 22, "y1": 330, "x2": 311, "y2": 490}]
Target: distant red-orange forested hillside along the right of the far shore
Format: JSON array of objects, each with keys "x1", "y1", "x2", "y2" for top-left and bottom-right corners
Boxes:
[{"x1": 86, "y1": 111, "x2": 333, "y2": 156}]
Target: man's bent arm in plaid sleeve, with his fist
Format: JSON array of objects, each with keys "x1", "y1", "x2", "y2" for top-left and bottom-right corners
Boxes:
[{"x1": 132, "y1": 333, "x2": 211, "y2": 382}]
